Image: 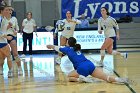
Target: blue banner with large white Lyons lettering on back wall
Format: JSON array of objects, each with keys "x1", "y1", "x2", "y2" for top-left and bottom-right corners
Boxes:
[{"x1": 61, "y1": 0, "x2": 140, "y2": 19}]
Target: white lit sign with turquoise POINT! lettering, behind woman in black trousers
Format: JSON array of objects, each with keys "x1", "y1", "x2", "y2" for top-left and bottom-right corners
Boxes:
[{"x1": 17, "y1": 32, "x2": 53, "y2": 51}]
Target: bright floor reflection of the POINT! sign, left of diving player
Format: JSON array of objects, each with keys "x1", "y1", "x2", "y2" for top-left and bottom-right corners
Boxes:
[{"x1": 3, "y1": 55, "x2": 54, "y2": 78}]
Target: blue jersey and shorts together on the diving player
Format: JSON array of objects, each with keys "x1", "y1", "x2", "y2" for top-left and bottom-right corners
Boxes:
[{"x1": 59, "y1": 46, "x2": 95, "y2": 76}]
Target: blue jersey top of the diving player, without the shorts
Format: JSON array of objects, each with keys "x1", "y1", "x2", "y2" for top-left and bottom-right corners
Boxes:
[{"x1": 59, "y1": 46, "x2": 88, "y2": 69}]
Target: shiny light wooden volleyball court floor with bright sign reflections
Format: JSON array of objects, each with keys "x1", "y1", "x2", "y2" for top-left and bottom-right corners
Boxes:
[{"x1": 0, "y1": 52, "x2": 140, "y2": 93}]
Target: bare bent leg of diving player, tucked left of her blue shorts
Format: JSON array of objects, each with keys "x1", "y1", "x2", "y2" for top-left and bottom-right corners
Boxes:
[{"x1": 68, "y1": 70, "x2": 79, "y2": 82}]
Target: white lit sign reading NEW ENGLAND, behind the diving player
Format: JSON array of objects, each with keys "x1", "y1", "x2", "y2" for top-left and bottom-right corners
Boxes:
[{"x1": 58, "y1": 30, "x2": 105, "y2": 49}]
